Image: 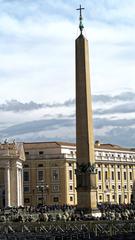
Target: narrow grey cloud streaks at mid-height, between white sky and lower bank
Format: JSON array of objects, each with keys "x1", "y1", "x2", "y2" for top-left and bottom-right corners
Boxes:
[{"x1": 0, "y1": 92, "x2": 135, "y2": 114}]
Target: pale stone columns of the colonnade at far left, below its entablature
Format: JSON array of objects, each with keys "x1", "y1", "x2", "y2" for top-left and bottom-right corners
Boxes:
[{"x1": 0, "y1": 160, "x2": 23, "y2": 207}]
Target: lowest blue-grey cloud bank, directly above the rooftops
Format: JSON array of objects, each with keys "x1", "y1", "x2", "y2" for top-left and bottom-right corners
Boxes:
[{"x1": 0, "y1": 113, "x2": 135, "y2": 147}]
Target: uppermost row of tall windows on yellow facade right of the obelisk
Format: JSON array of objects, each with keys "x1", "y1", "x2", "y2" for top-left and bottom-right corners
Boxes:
[{"x1": 98, "y1": 171, "x2": 132, "y2": 180}]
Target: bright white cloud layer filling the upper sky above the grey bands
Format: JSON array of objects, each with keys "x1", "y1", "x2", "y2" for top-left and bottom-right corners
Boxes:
[{"x1": 0, "y1": 0, "x2": 135, "y2": 102}]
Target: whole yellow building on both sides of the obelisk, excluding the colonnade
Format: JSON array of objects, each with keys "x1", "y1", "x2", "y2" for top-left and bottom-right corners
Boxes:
[{"x1": 23, "y1": 142, "x2": 135, "y2": 205}]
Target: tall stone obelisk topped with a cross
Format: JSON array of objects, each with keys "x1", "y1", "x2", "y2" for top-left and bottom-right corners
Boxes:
[{"x1": 75, "y1": 5, "x2": 97, "y2": 212}]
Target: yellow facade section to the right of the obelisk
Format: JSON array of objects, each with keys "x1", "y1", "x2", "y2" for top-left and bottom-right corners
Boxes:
[{"x1": 95, "y1": 142, "x2": 135, "y2": 204}]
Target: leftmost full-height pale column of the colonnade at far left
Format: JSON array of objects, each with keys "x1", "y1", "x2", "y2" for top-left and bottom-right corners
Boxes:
[{"x1": 4, "y1": 167, "x2": 10, "y2": 207}]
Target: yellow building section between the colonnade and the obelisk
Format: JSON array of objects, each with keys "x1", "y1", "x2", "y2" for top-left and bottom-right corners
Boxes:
[{"x1": 23, "y1": 142, "x2": 77, "y2": 205}]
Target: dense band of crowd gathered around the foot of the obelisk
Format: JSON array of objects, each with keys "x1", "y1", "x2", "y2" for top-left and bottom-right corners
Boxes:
[{"x1": 0, "y1": 204, "x2": 135, "y2": 222}]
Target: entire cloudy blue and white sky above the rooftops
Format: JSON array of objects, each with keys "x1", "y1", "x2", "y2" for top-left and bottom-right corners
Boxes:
[{"x1": 0, "y1": 0, "x2": 135, "y2": 147}]
